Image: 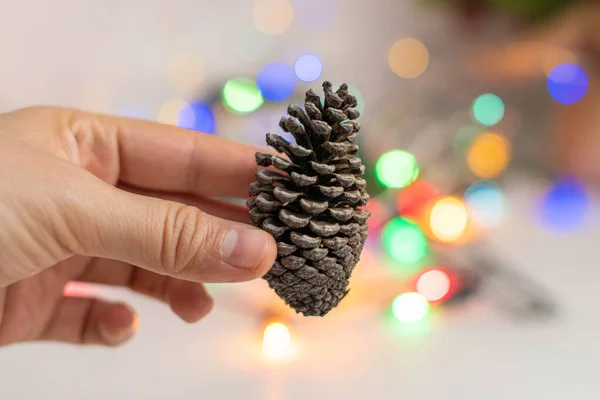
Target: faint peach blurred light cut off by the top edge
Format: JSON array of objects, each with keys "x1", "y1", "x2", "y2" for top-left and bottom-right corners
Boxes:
[{"x1": 253, "y1": 0, "x2": 294, "y2": 35}]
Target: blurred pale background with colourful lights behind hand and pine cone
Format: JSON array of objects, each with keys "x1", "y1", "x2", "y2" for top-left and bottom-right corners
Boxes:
[{"x1": 0, "y1": 0, "x2": 600, "y2": 400}]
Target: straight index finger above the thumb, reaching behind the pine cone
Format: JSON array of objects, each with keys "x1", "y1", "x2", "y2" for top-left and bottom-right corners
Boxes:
[{"x1": 105, "y1": 117, "x2": 260, "y2": 198}]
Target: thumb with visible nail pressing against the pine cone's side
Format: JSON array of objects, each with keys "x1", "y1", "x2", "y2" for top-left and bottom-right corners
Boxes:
[{"x1": 63, "y1": 179, "x2": 277, "y2": 282}]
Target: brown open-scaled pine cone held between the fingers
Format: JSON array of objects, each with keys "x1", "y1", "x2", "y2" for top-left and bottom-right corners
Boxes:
[{"x1": 248, "y1": 82, "x2": 370, "y2": 316}]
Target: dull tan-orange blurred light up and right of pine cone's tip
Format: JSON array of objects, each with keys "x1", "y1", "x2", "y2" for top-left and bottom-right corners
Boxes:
[{"x1": 388, "y1": 38, "x2": 429, "y2": 79}]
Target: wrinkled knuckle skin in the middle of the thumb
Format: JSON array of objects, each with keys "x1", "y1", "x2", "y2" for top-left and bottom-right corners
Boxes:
[{"x1": 161, "y1": 205, "x2": 214, "y2": 275}]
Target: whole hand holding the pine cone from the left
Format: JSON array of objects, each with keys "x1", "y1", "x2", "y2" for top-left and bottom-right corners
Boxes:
[{"x1": 0, "y1": 108, "x2": 276, "y2": 345}]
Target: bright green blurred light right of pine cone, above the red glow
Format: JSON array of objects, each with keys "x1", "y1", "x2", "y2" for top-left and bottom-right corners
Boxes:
[{"x1": 375, "y1": 150, "x2": 419, "y2": 189}]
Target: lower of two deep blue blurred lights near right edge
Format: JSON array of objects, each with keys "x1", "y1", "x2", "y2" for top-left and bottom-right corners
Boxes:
[{"x1": 539, "y1": 177, "x2": 590, "y2": 232}]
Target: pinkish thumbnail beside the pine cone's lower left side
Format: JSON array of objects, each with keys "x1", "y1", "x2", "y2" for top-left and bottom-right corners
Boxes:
[{"x1": 221, "y1": 228, "x2": 269, "y2": 269}]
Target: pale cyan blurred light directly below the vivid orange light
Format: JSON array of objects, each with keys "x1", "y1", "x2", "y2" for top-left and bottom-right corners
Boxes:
[{"x1": 463, "y1": 181, "x2": 506, "y2": 229}]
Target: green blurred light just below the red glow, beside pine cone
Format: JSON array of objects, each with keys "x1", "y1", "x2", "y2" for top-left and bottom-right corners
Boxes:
[{"x1": 381, "y1": 218, "x2": 428, "y2": 264}]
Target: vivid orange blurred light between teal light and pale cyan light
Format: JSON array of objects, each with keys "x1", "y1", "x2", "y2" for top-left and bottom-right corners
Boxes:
[{"x1": 467, "y1": 133, "x2": 510, "y2": 179}]
